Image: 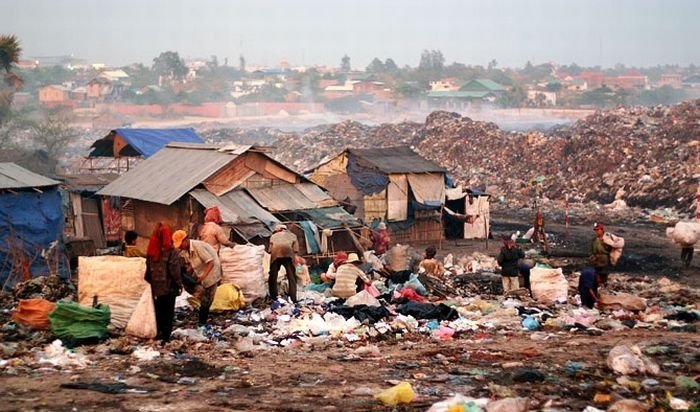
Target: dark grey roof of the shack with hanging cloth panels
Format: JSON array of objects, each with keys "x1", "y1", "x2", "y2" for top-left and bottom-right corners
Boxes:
[{"x1": 347, "y1": 146, "x2": 447, "y2": 173}]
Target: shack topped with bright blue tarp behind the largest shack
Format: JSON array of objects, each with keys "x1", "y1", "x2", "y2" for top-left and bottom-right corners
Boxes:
[{"x1": 80, "y1": 128, "x2": 204, "y2": 174}]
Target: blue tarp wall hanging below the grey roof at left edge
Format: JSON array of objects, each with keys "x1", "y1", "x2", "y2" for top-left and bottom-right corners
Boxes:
[{"x1": 0, "y1": 187, "x2": 68, "y2": 285}]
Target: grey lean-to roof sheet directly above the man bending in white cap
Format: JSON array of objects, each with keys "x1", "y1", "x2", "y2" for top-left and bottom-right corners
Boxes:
[{"x1": 190, "y1": 189, "x2": 279, "y2": 229}]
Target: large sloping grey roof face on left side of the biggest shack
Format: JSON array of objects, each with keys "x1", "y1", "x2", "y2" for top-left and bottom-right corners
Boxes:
[{"x1": 97, "y1": 146, "x2": 237, "y2": 205}]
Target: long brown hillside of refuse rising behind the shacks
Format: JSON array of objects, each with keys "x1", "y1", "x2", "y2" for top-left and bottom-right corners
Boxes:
[{"x1": 205, "y1": 100, "x2": 700, "y2": 212}]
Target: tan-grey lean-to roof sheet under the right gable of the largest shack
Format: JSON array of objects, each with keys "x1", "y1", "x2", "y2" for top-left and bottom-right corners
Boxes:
[{"x1": 247, "y1": 183, "x2": 338, "y2": 212}]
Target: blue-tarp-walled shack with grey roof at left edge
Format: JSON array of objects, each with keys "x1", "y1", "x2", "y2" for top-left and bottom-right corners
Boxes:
[{"x1": 0, "y1": 163, "x2": 68, "y2": 290}]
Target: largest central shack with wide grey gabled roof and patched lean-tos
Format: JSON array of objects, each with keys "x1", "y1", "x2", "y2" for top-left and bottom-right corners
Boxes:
[{"x1": 98, "y1": 143, "x2": 360, "y2": 253}]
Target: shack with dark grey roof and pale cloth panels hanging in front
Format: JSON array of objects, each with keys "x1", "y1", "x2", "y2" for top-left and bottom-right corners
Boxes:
[{"x1": 309, "y1": 146, "x2": 446, "y2": 242}]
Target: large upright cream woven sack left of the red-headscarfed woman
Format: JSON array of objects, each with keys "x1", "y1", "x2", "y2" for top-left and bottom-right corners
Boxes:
[{"x1": 78, "y1": 256, "x2": 148, "y2": 328}]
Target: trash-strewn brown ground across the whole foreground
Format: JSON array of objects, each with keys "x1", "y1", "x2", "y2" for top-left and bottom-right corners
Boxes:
[{"x1": 0, "y1": 230, "x2": 700, "y2": 411}]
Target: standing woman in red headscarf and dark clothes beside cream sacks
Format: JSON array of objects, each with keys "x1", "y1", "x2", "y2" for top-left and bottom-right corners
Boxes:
[{"x1": 145, "y1": 222, "x2": 182, "y2": 342}]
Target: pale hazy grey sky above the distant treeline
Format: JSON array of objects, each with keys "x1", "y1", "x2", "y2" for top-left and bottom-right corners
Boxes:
[{"x1": 0, "y1": 0, "x2": 700, "y2": 68}]
